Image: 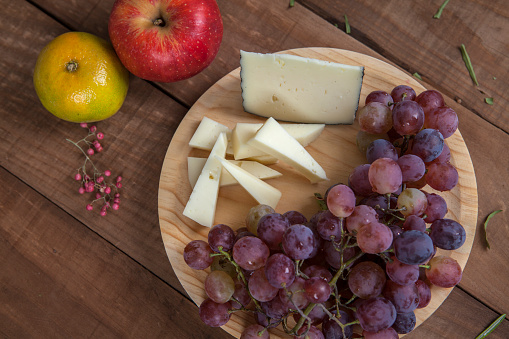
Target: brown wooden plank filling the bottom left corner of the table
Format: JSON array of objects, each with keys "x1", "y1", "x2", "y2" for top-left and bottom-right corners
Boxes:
[{"x1": 0, "y1": 169, "x2": 230, "y2": 338}]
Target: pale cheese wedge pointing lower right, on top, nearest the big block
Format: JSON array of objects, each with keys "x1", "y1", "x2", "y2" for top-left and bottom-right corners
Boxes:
[{"x1": 249, "y1": 118, "x2": 328, "y2": 183}]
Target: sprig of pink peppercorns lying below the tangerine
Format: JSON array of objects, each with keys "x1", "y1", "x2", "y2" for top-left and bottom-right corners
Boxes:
[{"x1": 66, "y1": 123, "x2": 122, "y2": 216}]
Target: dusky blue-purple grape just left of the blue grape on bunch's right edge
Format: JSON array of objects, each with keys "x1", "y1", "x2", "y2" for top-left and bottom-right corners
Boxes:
[{"x1": 393, "y1": 230, "x2": 435, "y2": 265}]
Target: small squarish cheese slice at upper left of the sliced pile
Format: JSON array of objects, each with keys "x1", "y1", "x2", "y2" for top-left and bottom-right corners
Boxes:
[{"x1": 189, "y1": 117, "x2": 233, "y2": 154}]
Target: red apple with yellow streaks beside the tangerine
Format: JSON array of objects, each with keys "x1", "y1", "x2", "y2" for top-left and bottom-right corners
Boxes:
[{"x1": 108, "y1": 0, "x2": 223, "y2": 82}]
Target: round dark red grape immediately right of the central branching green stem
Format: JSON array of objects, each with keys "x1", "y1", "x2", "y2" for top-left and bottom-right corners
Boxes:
[{"x1": 348, "y1": 261, "x2": 386, "y2": 299}]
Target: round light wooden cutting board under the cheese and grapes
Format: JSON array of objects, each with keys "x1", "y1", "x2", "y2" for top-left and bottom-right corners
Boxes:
[{"x1": 158, "y1": 48, "x2": 477, "y2": 338}]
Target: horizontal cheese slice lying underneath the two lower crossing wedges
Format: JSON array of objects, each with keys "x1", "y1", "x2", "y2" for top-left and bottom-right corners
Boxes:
[{"x1": 187, "y1": 157, "x2": 282, "y2": 187}]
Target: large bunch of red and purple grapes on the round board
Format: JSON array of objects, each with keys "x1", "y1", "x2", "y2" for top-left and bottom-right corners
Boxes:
[{"x1": 184, "y1": 86, "x2": 466, "y2": 339}]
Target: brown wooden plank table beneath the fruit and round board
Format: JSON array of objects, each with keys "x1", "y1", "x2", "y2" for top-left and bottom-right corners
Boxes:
[{"x1": 0, "y1": 0, "x2": 509, "y2": 338}]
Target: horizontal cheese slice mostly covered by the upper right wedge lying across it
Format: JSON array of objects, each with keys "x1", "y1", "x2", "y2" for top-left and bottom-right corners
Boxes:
[{"x1": 232, "y1": 122, "x2": 325, "y2": 159}]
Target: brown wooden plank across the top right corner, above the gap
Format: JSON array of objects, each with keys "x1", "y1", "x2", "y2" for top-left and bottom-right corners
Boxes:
[{"x1": 299, "y1": 0, "x2": 509, "y2": 132}]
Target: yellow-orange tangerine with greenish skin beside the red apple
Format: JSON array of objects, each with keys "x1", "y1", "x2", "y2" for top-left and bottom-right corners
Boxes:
[{"x1": 34, "y1": 32, "x2": 129, "y2": 122}]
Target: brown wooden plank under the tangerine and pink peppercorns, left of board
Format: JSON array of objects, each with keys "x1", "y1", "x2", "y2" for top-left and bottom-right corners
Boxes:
[{"x1": 0, "y1": 0, "x2": 186, "y2": 291}]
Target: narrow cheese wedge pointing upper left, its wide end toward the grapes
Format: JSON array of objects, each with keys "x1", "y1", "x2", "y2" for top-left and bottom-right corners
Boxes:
[{"x1": 216, "y1": 156, "x2": 281, "y2": 208}]
